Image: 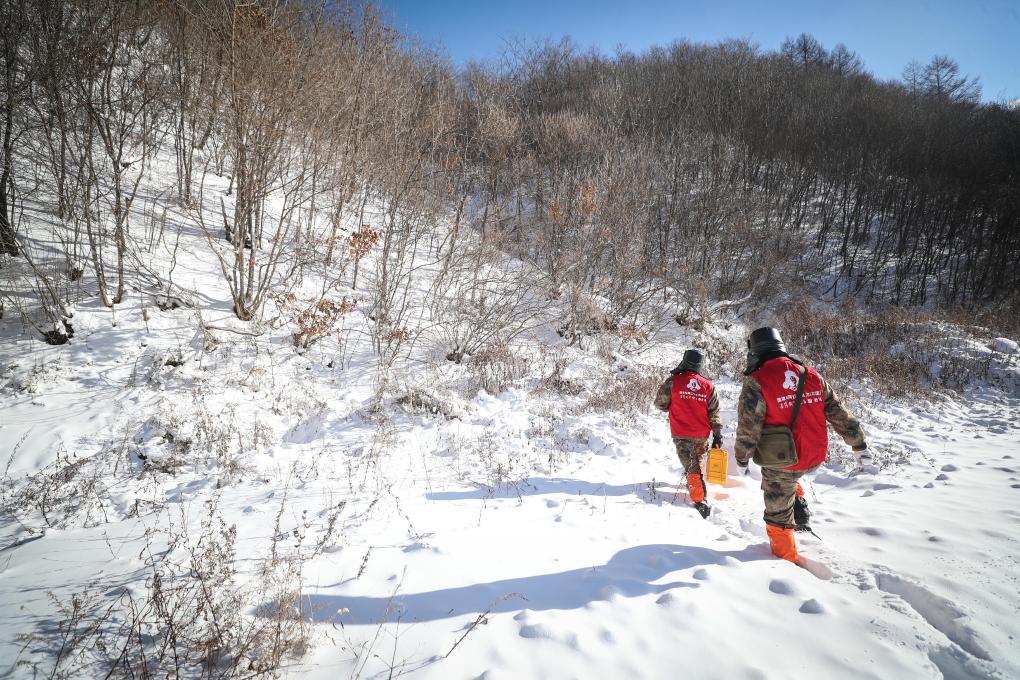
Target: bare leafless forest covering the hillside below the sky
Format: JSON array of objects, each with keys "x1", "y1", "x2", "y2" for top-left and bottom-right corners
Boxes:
[{"x1": 0, "y1": 0, "x2": 1020, "y2": 353}]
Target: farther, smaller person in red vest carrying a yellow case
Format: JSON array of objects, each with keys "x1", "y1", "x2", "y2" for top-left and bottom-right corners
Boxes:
[{"x1": 655, "y1": 350, "x2": 722, "y2": 519}]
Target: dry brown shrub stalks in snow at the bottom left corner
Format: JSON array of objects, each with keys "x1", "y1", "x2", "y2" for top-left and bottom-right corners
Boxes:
[{"x1": 17, "y1": 496, "x2": 343, "y2": 679}]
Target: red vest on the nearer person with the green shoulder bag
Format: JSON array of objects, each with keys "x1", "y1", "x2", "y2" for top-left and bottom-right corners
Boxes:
[{"x1": 752, "y1": 357, "x2": 828, "y2": 470}]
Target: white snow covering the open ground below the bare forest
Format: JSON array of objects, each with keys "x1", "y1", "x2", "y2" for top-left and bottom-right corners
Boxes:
[{"x1": 0, "y1": 149, "x2": 1020, "y2": 680}]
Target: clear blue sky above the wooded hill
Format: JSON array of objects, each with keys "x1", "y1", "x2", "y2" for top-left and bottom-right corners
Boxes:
[{"x1": 378, "y1": 0, "x2": 1020, "y2": 101}]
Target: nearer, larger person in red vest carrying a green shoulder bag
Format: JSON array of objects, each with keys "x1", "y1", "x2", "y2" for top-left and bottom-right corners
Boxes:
[{"x1": 734, "y1": 327, "x2": 873, "y2": 562}]
